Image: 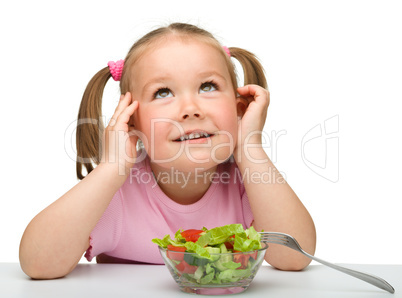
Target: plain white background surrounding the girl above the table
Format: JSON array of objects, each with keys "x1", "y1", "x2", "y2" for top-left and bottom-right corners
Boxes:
[{"x1": 0, "y1": 0, "x2": 402, "y2": 264}]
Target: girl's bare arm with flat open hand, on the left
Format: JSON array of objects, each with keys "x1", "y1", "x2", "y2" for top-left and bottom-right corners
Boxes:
[{"x1": 20, "y1": 93, "x2": 138, "y2": 279}]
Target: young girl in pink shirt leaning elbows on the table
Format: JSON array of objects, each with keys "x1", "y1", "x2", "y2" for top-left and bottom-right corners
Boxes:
[{"x1": 20, "y1": 23, "x2": 316, "y2": 278}]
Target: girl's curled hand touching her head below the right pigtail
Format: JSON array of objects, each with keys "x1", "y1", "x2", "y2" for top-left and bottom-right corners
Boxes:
[{"x1": 235, "y1": 85, "x2": 269, "y2": 151}]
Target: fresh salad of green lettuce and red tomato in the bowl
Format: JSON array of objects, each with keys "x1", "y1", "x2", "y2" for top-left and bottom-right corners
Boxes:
[{"x1": 152, "y1": 224, "x2": 262, "y2": 284}]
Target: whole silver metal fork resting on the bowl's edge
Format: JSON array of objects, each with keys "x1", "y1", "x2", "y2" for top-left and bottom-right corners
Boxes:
[{"x1": 260, "y1": 232, "x2": 395, "y2": 293}]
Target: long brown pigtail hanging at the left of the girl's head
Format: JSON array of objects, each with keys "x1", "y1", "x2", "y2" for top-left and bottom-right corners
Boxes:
[{"x1": 76, "y1": 67, "x2": 111, "y2": 180}]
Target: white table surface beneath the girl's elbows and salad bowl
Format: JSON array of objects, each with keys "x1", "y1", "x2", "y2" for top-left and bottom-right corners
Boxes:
[{"x1": 0, "y1": 263, "x2": 402, "y2": 298}]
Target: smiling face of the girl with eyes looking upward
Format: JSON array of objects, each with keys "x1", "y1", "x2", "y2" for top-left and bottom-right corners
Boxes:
[{"x1": 131, "y1": 38, "x2": 238, "y2": 172}]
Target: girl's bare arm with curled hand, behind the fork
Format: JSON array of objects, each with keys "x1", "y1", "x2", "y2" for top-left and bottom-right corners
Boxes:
[{"x1": 234, "y1": 85, "x2": 316, "y2": 270}]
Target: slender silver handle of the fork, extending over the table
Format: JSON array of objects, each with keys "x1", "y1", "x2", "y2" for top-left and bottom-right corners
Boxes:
[{"x1": 303, "y1": 251, "x2": 395, "y2": 294}]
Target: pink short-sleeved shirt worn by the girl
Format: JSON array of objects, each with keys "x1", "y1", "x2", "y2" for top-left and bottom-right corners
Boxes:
[{"x1": 85, "y1": 157, "x2": 253, "y2": 264}]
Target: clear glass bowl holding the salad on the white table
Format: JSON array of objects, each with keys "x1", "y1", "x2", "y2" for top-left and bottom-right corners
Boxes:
[{"x1": 159, "y1": 243, "x2": 268, "y2": 295}]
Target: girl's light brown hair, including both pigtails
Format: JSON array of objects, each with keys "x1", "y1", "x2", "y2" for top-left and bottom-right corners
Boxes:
[{"x1": 76, "y1": 23, "x2": 267, "y2": 179}]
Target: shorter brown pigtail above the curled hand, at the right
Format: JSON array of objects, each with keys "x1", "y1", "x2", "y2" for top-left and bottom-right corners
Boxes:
[{"x1": 229, "y1": 47, "x2": 268, "y2": 89}]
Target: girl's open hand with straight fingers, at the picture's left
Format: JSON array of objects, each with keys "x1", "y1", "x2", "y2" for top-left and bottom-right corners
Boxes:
[{"x1": 101, "y1": 92, "x2": 138, "y2": 175}]
